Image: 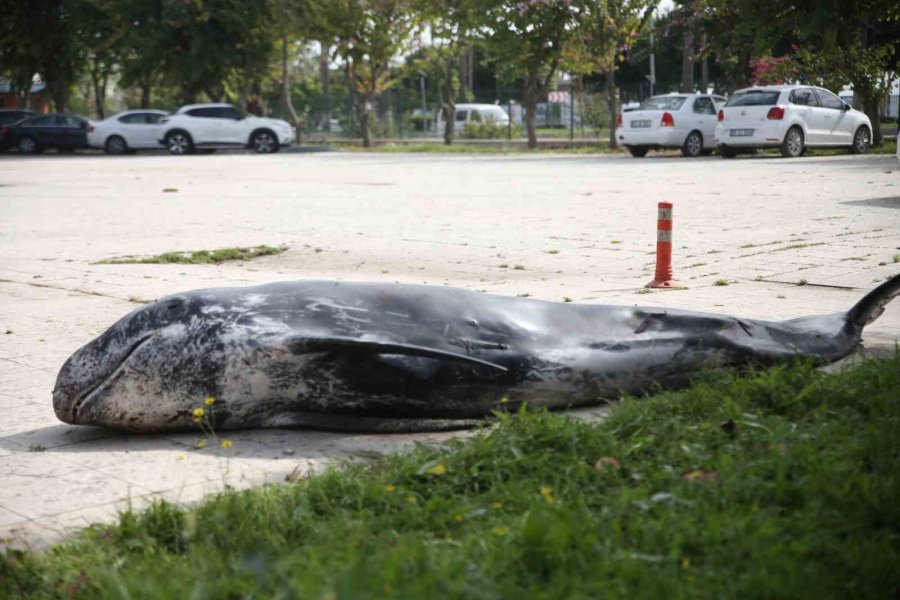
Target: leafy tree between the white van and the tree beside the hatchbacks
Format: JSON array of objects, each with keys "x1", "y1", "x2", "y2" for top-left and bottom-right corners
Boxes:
[{"x1": 479, "y1": 0, "x2": 581, "y2": 148}]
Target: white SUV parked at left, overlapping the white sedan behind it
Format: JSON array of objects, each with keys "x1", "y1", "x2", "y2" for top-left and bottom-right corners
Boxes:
[{"x1": 159, "y1": 104, "x2": 296, "y2": 154}]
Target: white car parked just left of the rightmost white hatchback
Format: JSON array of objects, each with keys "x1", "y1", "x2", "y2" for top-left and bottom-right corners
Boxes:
[{"x1": 616, "y1": 94, "x2": 725, "y2": 158}]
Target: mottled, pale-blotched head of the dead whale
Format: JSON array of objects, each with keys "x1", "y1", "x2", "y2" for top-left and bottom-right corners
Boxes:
[{"x1": 53, "y1": 294, "x2": 237, "y2": 430}]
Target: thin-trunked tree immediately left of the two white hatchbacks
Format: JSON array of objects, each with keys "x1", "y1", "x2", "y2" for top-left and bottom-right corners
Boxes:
[{"x1": 563, "y1": 0, "x2": 655, "y2": 148}]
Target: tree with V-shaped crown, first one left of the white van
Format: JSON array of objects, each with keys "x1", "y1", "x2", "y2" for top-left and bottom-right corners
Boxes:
[{"x1": 327, "y1": 0, "x2": 419, "y2": 148}]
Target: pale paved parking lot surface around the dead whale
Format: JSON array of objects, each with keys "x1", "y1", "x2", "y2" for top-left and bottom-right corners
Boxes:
[{"x1": 0, "y1": 153, "x2": 900, "y2": 544}]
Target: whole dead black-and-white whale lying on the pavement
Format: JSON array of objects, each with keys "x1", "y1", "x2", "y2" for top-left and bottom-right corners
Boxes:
[{"x1": 53, "y1": 275, "x2": 900, "y2": 431}]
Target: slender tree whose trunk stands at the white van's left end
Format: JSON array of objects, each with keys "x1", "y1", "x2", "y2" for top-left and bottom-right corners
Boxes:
[{"x1": 413, "y1": 0, "x2": 478, "y2": 146}]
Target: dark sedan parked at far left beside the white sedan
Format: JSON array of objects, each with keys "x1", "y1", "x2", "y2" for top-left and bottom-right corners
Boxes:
[{"x1": 0, "y1": 114, "x2": 88, "y2": 154}]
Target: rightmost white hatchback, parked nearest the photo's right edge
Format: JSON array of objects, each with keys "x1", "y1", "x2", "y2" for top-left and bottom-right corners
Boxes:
[{"x1": 716, "y1": 85, "x2": 872, "y2": 158}]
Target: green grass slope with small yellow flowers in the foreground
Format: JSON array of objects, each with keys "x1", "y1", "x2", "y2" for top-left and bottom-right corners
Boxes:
[{"x1": 0, "y1": 354, "x2": 900, "y2": 599}]
